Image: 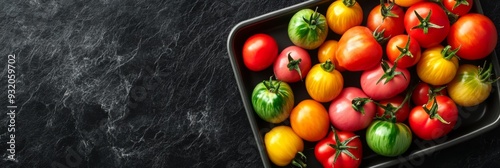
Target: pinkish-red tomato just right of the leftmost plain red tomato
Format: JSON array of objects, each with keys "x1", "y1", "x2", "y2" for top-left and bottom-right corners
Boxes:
[{"x1": 273, "y1": 46, "x2": 312, "y2": 83}]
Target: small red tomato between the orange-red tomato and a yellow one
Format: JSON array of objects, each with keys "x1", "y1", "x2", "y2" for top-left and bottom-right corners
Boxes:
[{"x1": 385, "y1": 34, "x2": 421, "y2": 68}]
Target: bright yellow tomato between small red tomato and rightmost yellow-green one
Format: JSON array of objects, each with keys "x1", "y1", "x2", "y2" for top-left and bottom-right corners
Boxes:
[{"x1": 416, "y1": 45, "x2": 458, "y2": 86}]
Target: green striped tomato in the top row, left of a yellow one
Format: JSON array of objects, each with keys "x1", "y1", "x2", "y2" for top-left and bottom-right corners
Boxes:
[{"x1": 288, "y1": 9, "x2": 329, "y2": 50}]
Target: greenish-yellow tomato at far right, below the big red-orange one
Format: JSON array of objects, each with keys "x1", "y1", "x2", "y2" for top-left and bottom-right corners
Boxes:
[{"x1": 447, "y1": 64, "x2": 498, "y2": 107}]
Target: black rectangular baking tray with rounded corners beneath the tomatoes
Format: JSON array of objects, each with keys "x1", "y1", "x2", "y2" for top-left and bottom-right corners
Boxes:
[{"x1": 227, "y1": 0, "x2": 500, "y2": 167}]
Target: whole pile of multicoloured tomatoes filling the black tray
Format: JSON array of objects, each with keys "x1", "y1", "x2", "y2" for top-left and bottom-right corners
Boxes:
[{"x1": 243, "y1": 0, "x2": 498, "y2": 167}]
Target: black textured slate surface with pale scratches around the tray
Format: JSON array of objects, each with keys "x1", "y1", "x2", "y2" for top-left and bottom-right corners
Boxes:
[{"x1": 0, "y1": 0, "x2": 500, "y2": 167}]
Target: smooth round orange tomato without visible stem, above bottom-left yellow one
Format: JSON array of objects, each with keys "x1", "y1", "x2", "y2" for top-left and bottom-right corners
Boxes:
[{"x1": 290, "y1": 99, "x2": 330, "y2": 142}]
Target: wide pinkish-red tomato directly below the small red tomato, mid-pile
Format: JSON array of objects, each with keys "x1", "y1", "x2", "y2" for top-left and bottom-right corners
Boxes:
[{"x1": 360, "y1": 61, "x2": 410, "y2": 100}]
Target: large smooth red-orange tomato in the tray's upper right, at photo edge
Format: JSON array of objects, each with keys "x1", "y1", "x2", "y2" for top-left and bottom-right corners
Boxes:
[{"x1": 447, "y1": 13, "x2": 498, "y2": 60}]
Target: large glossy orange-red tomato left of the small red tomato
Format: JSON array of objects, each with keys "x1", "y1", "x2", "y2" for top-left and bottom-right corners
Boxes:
[{"x1": 335, "y1": 25, "x2": 383, "y2": 71}]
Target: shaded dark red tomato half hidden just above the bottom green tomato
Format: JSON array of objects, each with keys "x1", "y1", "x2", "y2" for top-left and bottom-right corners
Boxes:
[{"x1": 377, "y1": 95, "x2": 410, "y2": 122}]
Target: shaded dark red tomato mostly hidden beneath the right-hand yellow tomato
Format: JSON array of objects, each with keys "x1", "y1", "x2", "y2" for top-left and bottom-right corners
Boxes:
[{"x1": 411, "y1": 81, "x2": 446, "y2": 106}]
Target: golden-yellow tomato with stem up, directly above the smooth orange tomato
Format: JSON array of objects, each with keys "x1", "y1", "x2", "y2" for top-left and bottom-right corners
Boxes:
[{"x1": 305, "y1": 60, "x2": 344, "y2": 103}]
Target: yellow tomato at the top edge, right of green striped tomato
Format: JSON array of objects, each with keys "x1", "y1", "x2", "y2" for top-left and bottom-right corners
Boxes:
[{"x1": 326, "y1": 0, "x2": 363, "y2": 35}]
